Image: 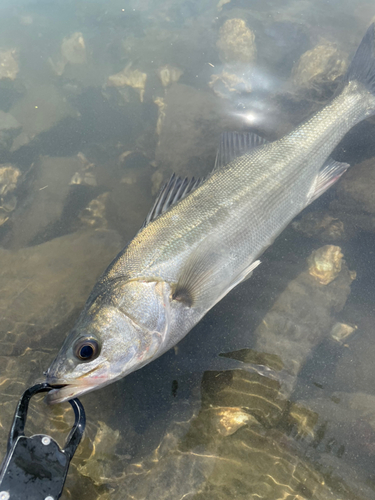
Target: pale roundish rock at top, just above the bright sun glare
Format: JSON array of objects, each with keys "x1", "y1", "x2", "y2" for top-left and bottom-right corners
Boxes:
[{"x1": 216, "y1": 19, "x2": 256, "y2": 63}]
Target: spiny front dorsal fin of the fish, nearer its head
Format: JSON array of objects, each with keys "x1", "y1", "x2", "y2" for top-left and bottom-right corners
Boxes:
[{"x1": 142, "y1": 174, "x2": 204, "y2": 228}]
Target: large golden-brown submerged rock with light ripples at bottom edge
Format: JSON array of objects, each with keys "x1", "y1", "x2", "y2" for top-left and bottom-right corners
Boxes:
[{"x1": 113, "y1": 370, "x2": 373, "y2": 500}]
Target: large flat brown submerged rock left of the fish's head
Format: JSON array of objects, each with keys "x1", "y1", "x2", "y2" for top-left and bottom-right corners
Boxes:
[{"x1": 0, "y1": 230, "x2": 121, "y2": 358}]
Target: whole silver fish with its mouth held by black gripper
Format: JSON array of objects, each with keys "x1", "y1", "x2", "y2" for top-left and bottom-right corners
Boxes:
[{"x1": 45, "y1": 24, "x2": 375, "y2": 403}]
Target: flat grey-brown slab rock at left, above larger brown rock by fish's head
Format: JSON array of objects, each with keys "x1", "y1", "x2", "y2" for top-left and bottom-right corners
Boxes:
[{"x1": 8, "y1": 156, "x2": 90, "y2": 248}]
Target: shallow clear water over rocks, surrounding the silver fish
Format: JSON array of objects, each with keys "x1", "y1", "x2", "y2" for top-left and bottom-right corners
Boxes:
[{"x1": 0, "y1": 0, "x2": 375, "y2": 500}]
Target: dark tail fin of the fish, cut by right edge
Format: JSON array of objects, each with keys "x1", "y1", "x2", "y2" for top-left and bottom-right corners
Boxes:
[{"x1": 347, "y1": 23, "x2": 375, "y2": 94}]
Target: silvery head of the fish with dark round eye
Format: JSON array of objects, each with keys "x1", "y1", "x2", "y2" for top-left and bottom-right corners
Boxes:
[{"x1": 46, "y1": 281, "x2": 172, "y2": 403}]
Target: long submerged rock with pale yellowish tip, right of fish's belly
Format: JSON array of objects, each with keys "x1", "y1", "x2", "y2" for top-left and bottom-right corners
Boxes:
[{"x1": 254, "y1": 246, "x2": 353, "y2": 386}]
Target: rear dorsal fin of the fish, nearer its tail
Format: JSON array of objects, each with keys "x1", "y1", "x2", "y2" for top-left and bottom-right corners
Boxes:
[{"x1": 214, "y1": 132, "x2": 268, "y2": 170}]
